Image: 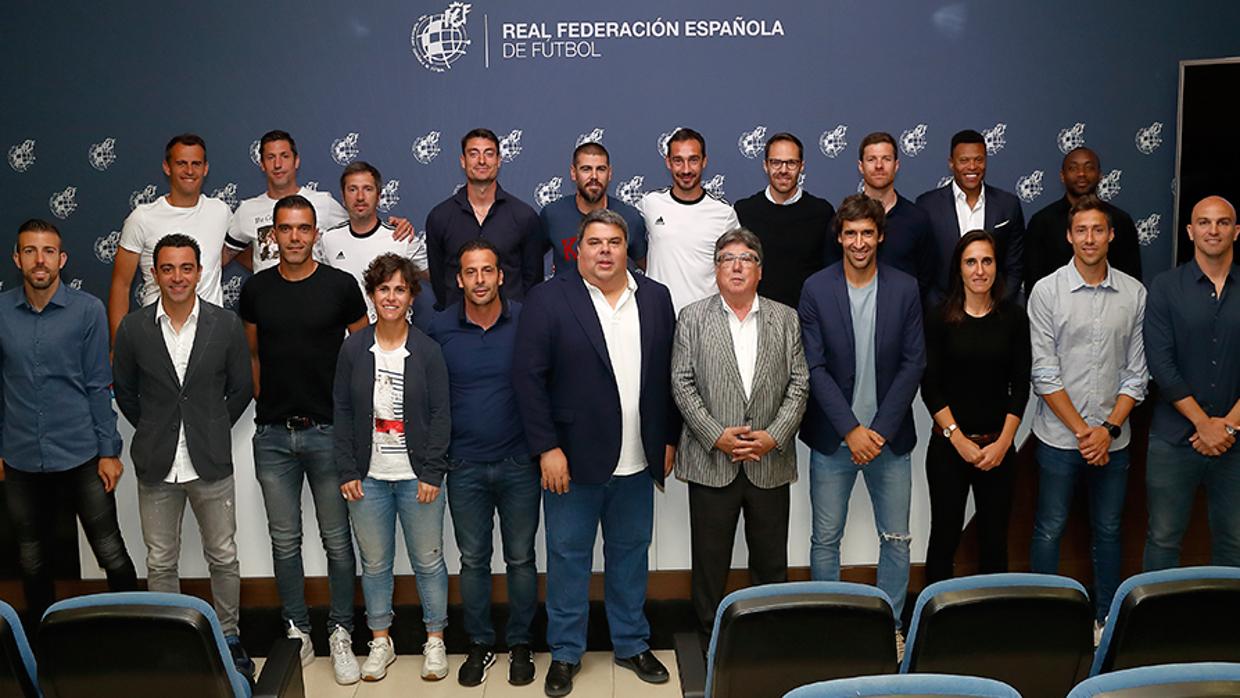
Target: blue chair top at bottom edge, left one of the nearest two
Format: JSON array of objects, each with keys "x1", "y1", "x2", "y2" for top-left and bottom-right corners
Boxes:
[{"x1": 784, "y1": 673, "x2": 1021, "y2": 698}]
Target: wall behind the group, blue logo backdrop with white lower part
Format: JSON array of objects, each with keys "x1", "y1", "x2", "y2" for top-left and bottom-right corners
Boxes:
[{"x1": 0, "y1": 0, "x2": 1240, "y2": 575}]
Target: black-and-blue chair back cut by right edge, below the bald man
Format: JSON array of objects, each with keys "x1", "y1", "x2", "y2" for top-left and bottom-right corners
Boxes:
[{"x1": 1090, "y1": 567, "x2": 1240, "y2": 676}]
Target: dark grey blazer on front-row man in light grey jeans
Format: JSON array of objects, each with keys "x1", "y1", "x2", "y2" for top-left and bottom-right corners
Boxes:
[{"x1": 112, "y1": 299, "x2": 254, "y2": 484}]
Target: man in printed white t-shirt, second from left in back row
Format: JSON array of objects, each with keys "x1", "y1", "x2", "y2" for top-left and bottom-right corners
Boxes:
[{"x1": 222, "y1": 130, "x2": 414, "y2": 272}]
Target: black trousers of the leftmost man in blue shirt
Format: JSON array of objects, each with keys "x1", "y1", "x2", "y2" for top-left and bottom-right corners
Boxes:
[{"x1": 4, "y1": 459, "x2": 138, "y2": 620}]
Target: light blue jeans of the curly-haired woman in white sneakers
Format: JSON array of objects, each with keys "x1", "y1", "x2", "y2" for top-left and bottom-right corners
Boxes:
[{"x1": 348, "y1": 477, "x2": 448, "y2": 632}]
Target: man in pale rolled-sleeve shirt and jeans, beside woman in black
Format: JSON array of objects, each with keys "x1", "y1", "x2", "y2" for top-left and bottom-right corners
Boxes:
[{"x1": 1029, "y1": 196, "x2": 1148, "y2": 641}]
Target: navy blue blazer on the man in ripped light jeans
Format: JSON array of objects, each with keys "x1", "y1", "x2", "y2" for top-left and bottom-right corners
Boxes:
[{"x1": 797, "y1": 262, "x2": 926, "y2": 455}]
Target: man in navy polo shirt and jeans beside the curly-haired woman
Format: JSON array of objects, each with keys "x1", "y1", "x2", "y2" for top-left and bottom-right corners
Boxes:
[{"x1": 429, "y1": 239, "x2": 542, "y2": 686}]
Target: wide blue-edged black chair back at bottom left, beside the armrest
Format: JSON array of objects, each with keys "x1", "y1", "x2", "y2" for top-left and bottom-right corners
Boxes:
[{"x1": 36, "y1": 591, "x2": 252, "y2": 698}]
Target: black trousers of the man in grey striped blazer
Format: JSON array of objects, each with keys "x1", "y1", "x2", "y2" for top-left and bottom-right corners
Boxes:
[{"x1": 689, "y1": 469, "x2": 789, "y2": 637}]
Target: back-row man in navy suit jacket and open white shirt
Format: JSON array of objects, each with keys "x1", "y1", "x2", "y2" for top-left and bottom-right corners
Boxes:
[{"x1": 918, "y1": 129, "x2": 1024, "y2": 305}]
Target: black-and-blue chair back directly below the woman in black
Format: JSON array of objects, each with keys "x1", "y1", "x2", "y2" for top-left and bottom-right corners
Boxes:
[{"x1": 900, "y1": 573, "x2": 1094, "y2": 698}]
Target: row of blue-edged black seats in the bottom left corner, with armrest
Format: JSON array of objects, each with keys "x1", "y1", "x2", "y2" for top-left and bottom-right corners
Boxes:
[{"x1": 0, "y1": 591, "x2": 305, "y2": 698}]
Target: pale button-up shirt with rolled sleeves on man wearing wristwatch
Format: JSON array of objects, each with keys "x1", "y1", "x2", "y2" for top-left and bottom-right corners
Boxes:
[{"x1": 1029, "y1": 260, "x2": 1149, "y2": 451}]
